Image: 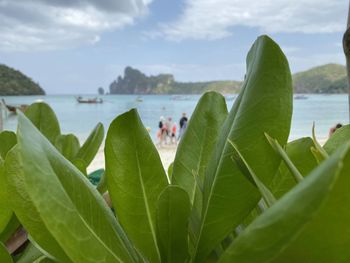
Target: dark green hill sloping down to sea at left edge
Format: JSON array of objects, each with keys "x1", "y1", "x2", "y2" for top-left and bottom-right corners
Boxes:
[{"x1": 0, "y1": 64, "x2": 45, "y2": 96}]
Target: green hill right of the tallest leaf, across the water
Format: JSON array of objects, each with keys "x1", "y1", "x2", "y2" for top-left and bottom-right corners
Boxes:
[{"x1": 293, "y1": 64, "x2": 347, "y2": 93}]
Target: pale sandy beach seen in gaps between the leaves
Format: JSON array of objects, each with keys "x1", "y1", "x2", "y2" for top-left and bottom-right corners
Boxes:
[{"x1": 87, "y1": 145, "x2": 177, "y2": 173}]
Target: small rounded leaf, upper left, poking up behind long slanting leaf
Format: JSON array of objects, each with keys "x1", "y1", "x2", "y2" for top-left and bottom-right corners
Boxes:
[{"x1": 25, "y1": 102, "x2": 61, "y2": 144}]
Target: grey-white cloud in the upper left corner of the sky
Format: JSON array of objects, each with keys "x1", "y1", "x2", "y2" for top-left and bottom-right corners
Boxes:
[{"x1": 0, "y1": 0, "x2": 152, "y2": 51}]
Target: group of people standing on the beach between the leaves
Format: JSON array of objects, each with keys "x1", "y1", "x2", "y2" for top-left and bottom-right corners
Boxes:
[{"x1": 157, "y1": 113, "x2": 188, "y2": 145}]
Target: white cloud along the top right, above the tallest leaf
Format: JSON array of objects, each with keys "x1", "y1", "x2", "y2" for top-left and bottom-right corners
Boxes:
[{"x1": 158, "y1": 0, "x2": 348, "y2": 41}]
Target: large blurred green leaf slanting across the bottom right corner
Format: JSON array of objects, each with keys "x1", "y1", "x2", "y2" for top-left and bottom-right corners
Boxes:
[{"x1": 219, "y1": 145, "x2": 350, "y2": 263}]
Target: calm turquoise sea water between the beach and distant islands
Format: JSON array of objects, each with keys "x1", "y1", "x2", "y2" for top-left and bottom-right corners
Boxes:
[{"x1": 4, "y1": 95, "x2": 349, "y2": 140}]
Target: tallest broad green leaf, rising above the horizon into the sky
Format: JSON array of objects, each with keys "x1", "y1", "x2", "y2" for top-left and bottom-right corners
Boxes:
[{"x1": 194, "y1": 36, "x2": 292, "y2": 262}]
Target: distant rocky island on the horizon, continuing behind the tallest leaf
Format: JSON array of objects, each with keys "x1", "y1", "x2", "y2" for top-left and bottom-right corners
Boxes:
[{"x1": 109, "y1": 64, "x2": 347, "y2": 94}]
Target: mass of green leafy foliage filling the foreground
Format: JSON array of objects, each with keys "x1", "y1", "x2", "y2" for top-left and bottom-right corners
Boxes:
[{"x1": 0, "y1": 36, "x2": 350, "y2": 263}]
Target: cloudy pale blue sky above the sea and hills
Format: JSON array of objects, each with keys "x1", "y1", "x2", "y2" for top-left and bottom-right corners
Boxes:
[{"x1": 0, "y1": 0, "x2": 349, "y2": 94}]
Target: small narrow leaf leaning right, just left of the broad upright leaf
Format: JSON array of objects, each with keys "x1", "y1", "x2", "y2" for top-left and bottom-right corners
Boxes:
[{"x1": 76, "y1": 123, "x2": 104, "y2": 166}]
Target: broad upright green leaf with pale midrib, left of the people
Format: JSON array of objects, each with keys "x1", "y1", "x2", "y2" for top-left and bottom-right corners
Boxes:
[{"x1": 105, "y1": 109, "x2": 168, "y2": 263}]
